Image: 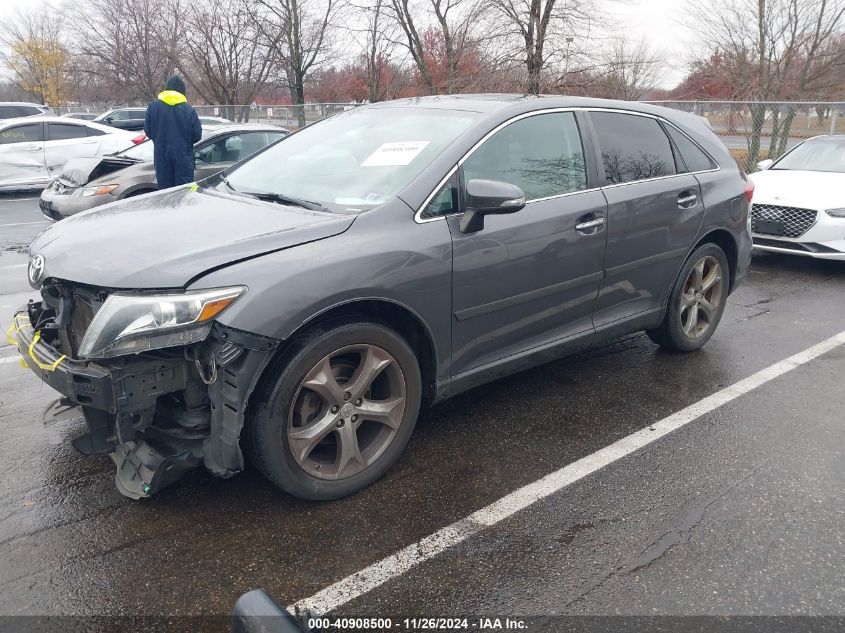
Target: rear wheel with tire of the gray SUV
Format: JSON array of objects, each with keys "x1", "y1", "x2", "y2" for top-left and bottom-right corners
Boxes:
[{"x1": 646, "y1": 244, "x2": 731, "y2": 352}]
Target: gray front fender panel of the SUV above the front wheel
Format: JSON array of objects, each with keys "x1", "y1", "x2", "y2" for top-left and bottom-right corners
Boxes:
[{"x1": 191, "y1": 200, "x2": 452, "y2": 379}]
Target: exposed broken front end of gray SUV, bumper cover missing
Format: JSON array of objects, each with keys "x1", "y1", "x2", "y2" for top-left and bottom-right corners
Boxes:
[{"x1": 8, "y1": 280, "x2": 279, "y2": 499}]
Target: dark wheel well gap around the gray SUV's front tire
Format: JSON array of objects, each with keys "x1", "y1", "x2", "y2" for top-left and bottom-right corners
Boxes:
[{"x1": 256, "y1": 299, "x2": 437, "y2": 402}]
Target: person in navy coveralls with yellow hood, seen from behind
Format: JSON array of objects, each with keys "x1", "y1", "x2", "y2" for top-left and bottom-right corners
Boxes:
[{"x1": 144, "y1": 76, "x2": 202, "y2": 189}]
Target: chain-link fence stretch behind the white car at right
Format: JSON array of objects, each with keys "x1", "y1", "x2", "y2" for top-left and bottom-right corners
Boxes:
[{"x1": 650, "y1": 101, "x2": 845, "y2": 172}]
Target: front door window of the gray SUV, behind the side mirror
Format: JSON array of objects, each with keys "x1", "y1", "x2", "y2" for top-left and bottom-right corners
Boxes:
[{"x1": 462, "y1": 112, "x2": 588, "y2": 201}]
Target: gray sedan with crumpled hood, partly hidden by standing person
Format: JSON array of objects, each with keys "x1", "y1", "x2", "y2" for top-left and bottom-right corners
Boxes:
[{"x1": 40, "y1": 123, "x2": 287, "y2": 220}]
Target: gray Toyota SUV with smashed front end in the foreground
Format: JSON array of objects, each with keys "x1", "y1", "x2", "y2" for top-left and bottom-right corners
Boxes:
[{"x1": 9, "y1": 95, "x2": 752, "y2": 499}]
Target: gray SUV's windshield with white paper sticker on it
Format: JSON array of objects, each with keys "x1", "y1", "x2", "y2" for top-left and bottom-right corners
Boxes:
[{"x1": 218, "y1": 107, "x2": 481, "y2": 213}]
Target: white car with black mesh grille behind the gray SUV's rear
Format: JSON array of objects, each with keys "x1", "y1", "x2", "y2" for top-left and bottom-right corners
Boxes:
[{"x1": 749, "y1": 136, "x2": 845, "y2": 260}]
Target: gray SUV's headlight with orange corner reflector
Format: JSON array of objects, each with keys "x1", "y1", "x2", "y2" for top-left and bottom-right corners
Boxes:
[{"x1": 79, "y1": 286, "x2": 246, "y2": 358}]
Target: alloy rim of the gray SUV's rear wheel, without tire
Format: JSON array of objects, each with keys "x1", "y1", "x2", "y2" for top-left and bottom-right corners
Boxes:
[{"x1": 679, "y1": 255, "x2": 724, "y2": 339}]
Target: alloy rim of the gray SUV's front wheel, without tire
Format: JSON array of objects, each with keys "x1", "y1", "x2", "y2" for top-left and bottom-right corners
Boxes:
[{"x1": 287, "y1": 344, "x2": 406, "y2": 480}]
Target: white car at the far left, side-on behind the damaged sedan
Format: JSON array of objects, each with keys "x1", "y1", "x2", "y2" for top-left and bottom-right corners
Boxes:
[{"x1": 0, "y1": 116, "x2": 138, "y2": 191}]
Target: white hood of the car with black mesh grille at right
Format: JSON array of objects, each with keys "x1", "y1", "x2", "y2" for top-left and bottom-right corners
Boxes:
[{"x1": 750, "y1": 169, "x2": 845, "y2": 210}]
